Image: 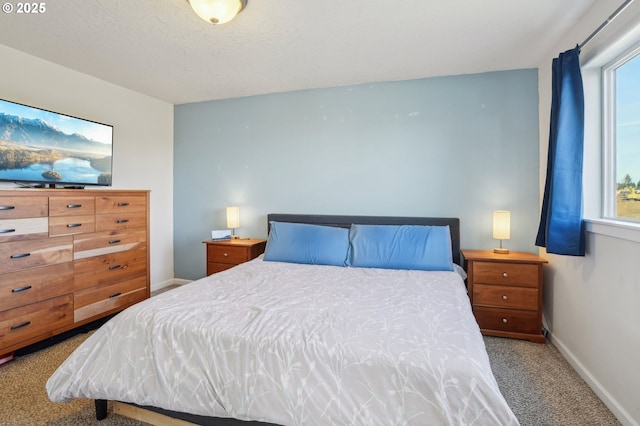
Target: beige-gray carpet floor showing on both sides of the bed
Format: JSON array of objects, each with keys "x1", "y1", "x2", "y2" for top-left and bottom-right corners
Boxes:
[{"x1": 0, "y1": 334, "x2": 620, "y2": 426}]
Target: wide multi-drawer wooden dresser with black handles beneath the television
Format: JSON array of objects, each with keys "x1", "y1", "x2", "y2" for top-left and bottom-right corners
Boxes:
[{"x1": 0, "y1": 189, "x2": 150, "y2": 355}]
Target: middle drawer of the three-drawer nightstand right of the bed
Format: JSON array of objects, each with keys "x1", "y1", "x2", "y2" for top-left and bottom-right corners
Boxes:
[{"x1": 473, "y1": 284, "x2": 538, "y2": 311}]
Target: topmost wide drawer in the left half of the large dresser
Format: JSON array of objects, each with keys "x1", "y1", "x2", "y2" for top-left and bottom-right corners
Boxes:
[{"x1": 0, "y1": 237, "x2": 73, "y2": 273}]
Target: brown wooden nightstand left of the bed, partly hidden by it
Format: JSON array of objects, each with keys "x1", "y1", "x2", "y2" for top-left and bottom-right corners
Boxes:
[{"x1": 203, "y1": 238, "x2": 267, "y2": 275}]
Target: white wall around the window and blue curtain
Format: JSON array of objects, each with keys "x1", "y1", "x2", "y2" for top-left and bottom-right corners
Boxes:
[{"x1": 538, "y1": 0, "x2": 640, "y2": 425}]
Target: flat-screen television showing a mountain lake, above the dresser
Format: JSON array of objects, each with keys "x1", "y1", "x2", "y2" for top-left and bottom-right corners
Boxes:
[{"x1": 0, "y1": 99, "x2": 113, "y2": 188}]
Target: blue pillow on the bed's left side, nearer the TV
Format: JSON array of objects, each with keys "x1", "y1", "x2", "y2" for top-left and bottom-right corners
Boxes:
[{"x1": 264, "y1": 222, "x2": 349, "y2": 266}]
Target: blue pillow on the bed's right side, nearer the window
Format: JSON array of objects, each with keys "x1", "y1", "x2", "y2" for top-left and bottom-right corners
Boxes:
[{"x1": 349, "y1": 225, "x2": 453, "y2": 271}]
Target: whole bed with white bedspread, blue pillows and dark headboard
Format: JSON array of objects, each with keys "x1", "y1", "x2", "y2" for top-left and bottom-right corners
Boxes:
[{"x1": 47, "y1": 214, "x2": 518, "y2": 425}]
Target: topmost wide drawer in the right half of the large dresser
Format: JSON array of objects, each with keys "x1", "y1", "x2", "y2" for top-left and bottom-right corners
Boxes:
[{"x1": 73, "y1": 228, "x2": 147, "y2": 259}]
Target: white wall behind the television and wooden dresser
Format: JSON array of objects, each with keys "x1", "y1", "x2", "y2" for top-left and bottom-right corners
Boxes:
[{"x1": 0, "y1": 45, "x2": 173, "y2": 288}]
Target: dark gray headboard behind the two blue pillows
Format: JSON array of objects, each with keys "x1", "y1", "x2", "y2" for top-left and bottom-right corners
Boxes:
[{"x1": 267, "y1": 213, "x2": 460, "y2": 265}]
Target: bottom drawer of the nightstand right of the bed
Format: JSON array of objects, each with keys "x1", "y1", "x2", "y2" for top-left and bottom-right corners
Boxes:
[{"x1": 473, "y1": 306, "x2": 542, "y2": 334}]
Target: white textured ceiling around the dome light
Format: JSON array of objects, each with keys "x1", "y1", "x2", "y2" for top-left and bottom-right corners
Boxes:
[{"x1": 0, "y1": 0, "x2": 595, "y2": 104}]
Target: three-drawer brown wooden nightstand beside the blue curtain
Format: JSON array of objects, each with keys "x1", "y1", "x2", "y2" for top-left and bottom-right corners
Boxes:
[{"x1": 461, "y1": 250, "x2": 547, "y2": 343}]
